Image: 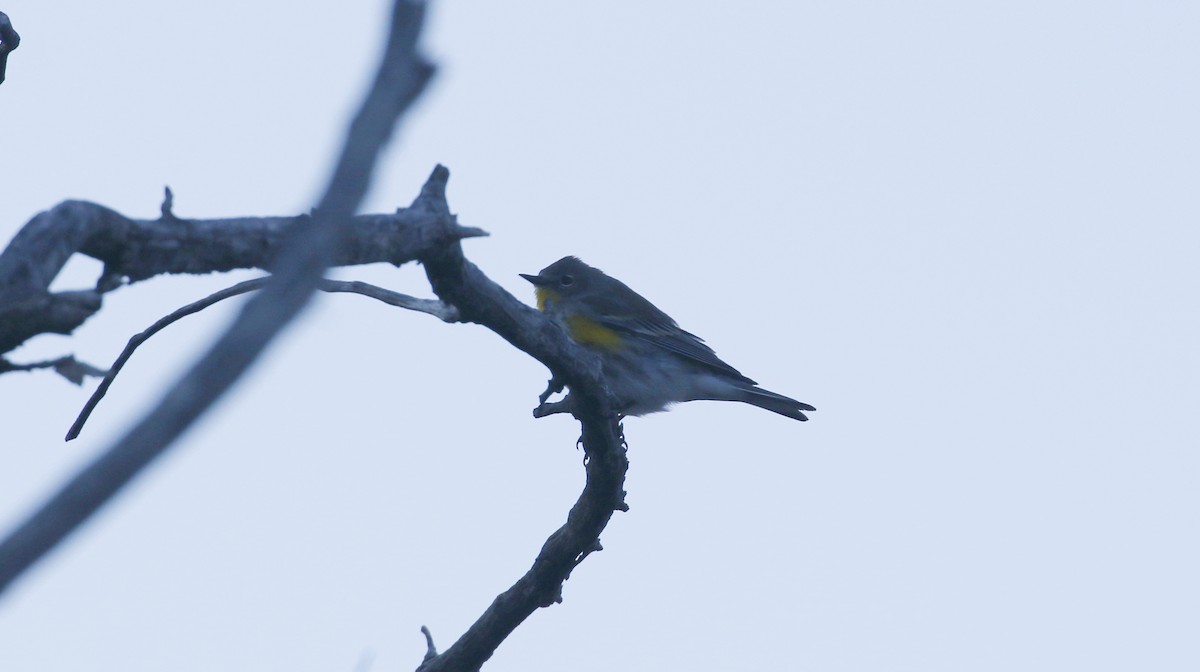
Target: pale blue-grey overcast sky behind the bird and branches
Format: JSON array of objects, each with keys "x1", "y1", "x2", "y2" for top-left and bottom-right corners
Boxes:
[{"x1": 0, "y1": 0, "x2": 1200, "y2": 672}]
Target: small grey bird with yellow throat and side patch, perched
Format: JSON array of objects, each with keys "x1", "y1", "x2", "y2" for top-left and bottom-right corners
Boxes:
[{"x1": 521, "y1": 257, "x2": 816, "y2": 420}]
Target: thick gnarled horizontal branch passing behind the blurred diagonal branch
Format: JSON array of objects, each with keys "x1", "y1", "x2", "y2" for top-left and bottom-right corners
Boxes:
[{"x1": 0, "y1": 199, "x2": 487, "y2": 353}]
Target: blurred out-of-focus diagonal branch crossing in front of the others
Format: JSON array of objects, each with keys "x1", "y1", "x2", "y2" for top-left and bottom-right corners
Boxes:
[{"x1": 0, "y1": 0, "x2": 433, "y2": 592}]
